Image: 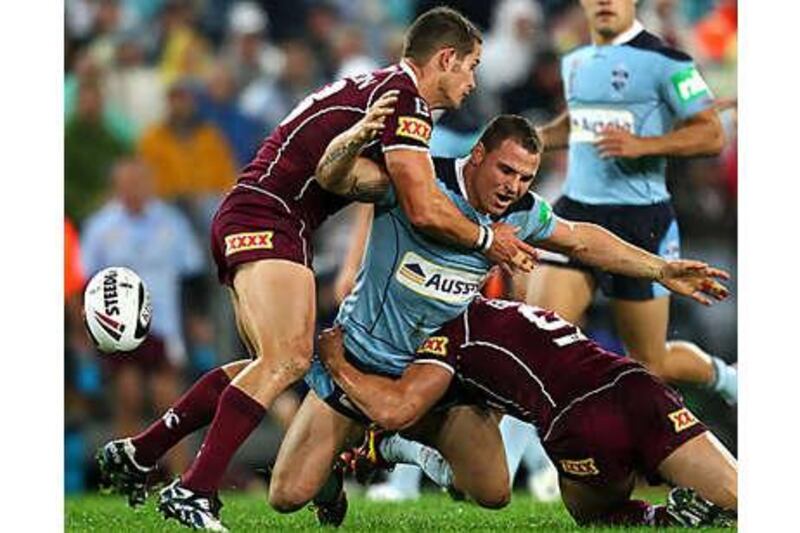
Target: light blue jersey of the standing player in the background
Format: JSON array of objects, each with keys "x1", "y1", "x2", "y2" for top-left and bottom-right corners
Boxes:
[{"x1": 561, "y1": 22, "x2": 713, "y2": 205}]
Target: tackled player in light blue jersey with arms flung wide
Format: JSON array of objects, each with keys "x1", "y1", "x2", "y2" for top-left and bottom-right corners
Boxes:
[{"x1": 269, "y1": 111, "x2": 727, "y2": 516}]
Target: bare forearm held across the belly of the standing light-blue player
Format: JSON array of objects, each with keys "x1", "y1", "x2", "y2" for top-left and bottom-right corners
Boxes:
[{"x1": 595, "y1": 108, "x2": 725, "y2": 158}]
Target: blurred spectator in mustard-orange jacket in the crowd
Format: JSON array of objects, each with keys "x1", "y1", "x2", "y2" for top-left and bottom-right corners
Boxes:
[{"x1": 138, "y1": 81, "x2": 236, "y2": 208}]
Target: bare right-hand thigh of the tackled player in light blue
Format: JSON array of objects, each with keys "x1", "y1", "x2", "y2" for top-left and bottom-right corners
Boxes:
[{"x1": 422, "y1": 405, "x2": 511, "y2": 508}]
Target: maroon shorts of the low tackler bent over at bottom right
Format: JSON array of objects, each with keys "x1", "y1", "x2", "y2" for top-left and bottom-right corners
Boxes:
[{"x1": 543, "y1": 369, "x2": 706, "y2": 486}]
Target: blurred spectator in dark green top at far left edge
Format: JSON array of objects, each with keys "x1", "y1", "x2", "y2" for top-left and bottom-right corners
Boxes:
[{"x1": 64, "y1": 77, "x2": 128, "y2": 223}]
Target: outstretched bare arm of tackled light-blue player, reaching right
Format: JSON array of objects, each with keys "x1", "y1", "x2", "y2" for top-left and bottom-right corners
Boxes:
[{"x1": 537, "y1": 219, "x2": 730, "y2": 305}]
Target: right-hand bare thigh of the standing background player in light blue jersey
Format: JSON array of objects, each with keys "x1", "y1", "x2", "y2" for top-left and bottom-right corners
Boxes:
[{"x1": 611, "y1": 296, "x2": 669, "y2": 366}]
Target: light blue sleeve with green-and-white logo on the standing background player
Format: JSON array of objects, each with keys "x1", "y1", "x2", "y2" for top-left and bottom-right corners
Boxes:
[{"x1": 661, "y1": 56, "x2": 714, "y2": 120}]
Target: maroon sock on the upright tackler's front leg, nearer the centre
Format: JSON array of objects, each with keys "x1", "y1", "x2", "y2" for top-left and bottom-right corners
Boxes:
[{"x1": 181, "y1": 385, "x2": 266, "y2": 494}]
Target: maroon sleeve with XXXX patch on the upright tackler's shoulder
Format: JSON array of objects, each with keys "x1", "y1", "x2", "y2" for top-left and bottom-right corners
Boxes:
[{"x1": 381, "y1": 89, "x2": 433, "y2": 152}]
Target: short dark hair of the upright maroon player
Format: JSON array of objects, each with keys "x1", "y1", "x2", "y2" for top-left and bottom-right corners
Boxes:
[{"x1": 403, "y1": 7, "x2": 483, "y2": 64}]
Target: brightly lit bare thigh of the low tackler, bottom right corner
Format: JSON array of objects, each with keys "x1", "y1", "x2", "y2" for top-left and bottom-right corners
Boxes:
[{"x1": 658, "y1": 431, "x2": 738, "y2": 509}]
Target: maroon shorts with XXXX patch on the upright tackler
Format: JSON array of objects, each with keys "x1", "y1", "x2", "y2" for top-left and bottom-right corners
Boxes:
[{"x1": 211, "y1": 184, "x2": 312, "y2": 286}]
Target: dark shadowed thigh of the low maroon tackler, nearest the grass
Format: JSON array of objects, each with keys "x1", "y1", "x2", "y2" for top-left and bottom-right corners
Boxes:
[{"x1": 558, "y1": 475, "x2": 635, "y2": 525}]
